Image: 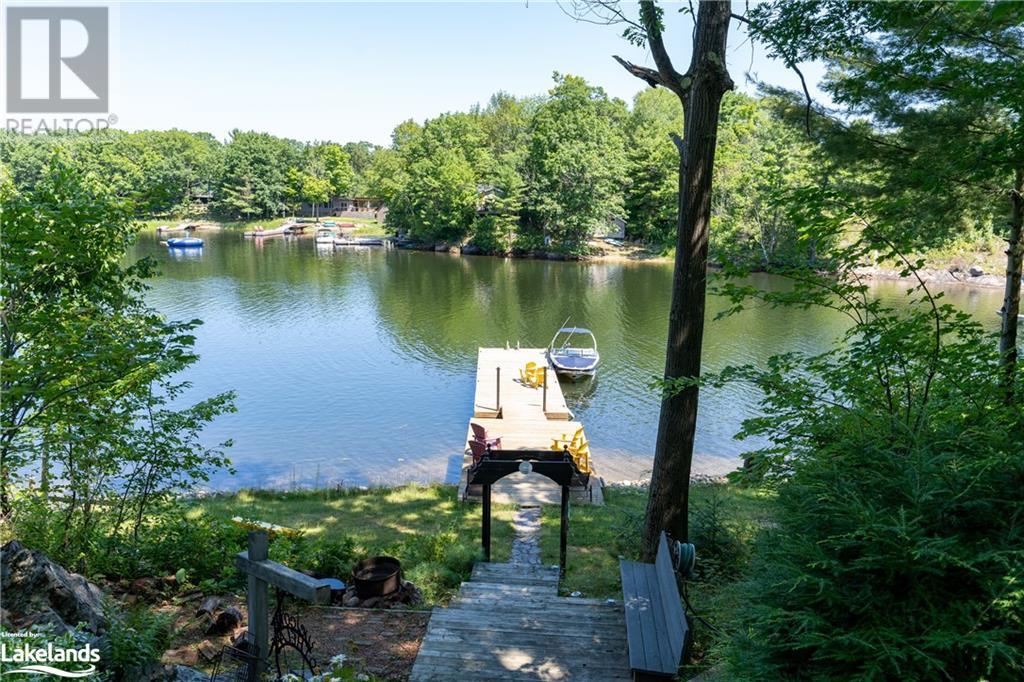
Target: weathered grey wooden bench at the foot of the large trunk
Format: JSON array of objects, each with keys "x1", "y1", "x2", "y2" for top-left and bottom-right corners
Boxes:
[{"x1": 618, "y1": 532, "x2": 689, "y2": 680}]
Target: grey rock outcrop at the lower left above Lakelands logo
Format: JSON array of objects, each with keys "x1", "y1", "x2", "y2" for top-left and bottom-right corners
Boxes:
[{"x1": 0, "y1": 540, "x2": 106, "y2": 634}]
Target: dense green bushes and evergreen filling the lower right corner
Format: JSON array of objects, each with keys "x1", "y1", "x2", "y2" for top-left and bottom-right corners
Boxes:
[{"x1": 712, "y1": 199, "x2": 1024, "y2": 680}]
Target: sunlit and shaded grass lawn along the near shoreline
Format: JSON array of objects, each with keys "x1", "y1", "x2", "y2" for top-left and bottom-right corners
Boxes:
[{"x1": 197, "y1": 485, "x2": 769, "y2": 602}]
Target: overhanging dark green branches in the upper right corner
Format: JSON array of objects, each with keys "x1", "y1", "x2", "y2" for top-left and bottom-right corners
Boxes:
[{"x1": 750, "y1": 0, "x2": 1024, "y2": 249}]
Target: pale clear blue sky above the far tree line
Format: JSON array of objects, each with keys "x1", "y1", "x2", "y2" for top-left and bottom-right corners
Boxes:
[{"x1": 113, "y1": 1, "x2": 821, "y2": 144}]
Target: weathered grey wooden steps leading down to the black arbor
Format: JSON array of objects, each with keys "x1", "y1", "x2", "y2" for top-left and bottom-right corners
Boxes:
[{"x1": 410, "y1": 563, "x2": 631, "y2": 682}]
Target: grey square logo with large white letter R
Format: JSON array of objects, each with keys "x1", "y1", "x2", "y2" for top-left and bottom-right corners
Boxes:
[{"x1": 5, "y1": 7, "x2": 111, "y2": 114}]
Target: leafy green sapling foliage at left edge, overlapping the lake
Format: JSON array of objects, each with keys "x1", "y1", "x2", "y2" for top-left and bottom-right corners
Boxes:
[{"x1": 0, "y1": 153, "x2": 233, "y2": 585}]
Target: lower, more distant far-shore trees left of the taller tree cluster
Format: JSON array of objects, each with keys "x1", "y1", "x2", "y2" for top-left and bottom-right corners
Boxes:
[{"x1": 0, "y1": 130, "x2": 376, "y2": 219}]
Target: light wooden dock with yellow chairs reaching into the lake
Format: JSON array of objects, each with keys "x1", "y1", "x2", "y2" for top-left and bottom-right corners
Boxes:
[{"x1": 459, "y1": 348, "x2": 604, "y2": 506}]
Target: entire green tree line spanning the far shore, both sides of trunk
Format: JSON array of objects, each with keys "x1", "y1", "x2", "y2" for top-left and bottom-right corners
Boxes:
[{"x1": 0, "y1": 67, "x2": 1006, "y2": 267}]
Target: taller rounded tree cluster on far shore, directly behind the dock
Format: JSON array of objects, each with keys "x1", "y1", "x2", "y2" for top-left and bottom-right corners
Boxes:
[{"x1": 367, "y1": 76, "x2": 627, "y2": 254}]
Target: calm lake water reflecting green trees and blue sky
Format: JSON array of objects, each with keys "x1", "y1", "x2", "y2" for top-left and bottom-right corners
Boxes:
[{"x1": 134, "y1": 232, "x2": 1001, "y2": 489}]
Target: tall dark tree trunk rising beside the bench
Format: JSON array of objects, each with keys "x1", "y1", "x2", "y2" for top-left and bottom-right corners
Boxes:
[{"x1": 643, "y1": 2, "x2": 732, "y2": 561}]
